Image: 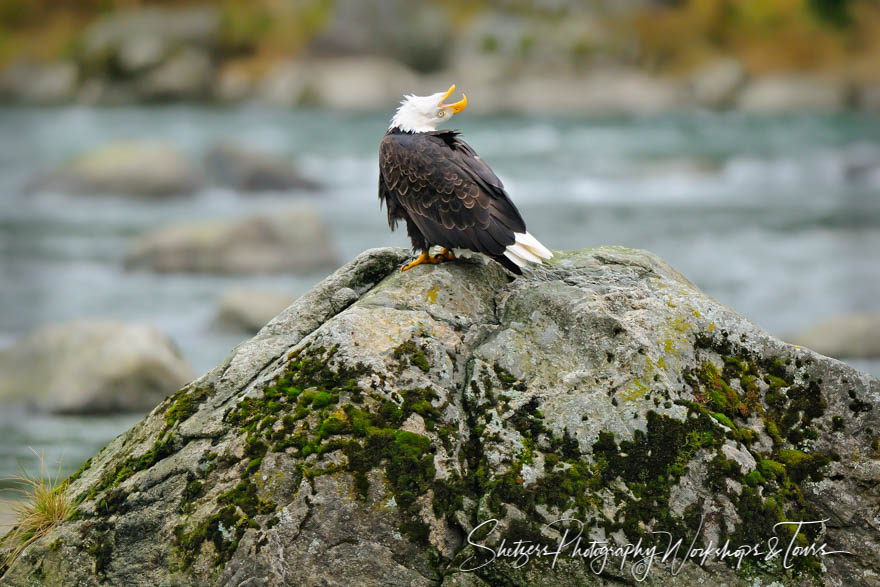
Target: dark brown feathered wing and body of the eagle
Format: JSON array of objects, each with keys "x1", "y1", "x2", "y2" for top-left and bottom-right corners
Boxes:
[{"x1": 379, "y1": 131, "x2": 525, "y2": 265}]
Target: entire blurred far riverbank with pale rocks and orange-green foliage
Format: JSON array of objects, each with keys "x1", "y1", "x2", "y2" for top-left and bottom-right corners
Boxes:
[{"x1": 0, "y1": 2, "x2": 880, "y2": 115}]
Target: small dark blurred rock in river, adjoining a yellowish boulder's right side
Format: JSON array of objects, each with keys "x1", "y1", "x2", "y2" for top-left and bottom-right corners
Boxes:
[{"x1": 205, "y1": 142, "x2": 318, "y2": 192}]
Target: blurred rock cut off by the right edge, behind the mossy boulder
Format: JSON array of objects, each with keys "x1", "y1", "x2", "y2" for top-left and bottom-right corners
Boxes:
[{"x1": 788, "y1": 314, "x2": 880, "y2": 359}]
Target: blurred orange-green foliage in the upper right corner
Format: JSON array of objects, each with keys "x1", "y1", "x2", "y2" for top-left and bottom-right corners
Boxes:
[{"x1": 617, "y1": 0, "x2": 880, "y2": 78}]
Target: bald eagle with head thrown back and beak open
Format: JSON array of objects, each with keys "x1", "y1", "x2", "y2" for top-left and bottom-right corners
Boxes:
[{"x1": 379, "y1": 85, "x2": 553, "y2": 275}]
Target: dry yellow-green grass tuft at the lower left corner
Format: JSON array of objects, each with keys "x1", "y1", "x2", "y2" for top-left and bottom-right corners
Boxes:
[{"x1": 0, "y1": 451, "x2": 73, "y2": 566}]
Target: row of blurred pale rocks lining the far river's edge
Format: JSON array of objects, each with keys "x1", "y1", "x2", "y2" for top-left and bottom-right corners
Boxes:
[{"x1": 0, "y1": 57, "x2": 880, "y2": 116}]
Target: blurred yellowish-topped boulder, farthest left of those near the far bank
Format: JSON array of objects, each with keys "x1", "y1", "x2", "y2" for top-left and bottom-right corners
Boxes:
[{"x1": 28, "y1": 142, "x2": 202, "y2": 197}]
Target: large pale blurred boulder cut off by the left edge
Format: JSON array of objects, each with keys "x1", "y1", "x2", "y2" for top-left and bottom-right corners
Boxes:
[{"x1": 0, "y1": 320, "x2": 193, "y2": 414}]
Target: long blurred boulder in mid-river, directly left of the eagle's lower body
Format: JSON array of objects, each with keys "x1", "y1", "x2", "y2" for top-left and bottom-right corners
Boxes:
[{"x1": 125, "y1": 204, "x2": 338, "y2": 274}]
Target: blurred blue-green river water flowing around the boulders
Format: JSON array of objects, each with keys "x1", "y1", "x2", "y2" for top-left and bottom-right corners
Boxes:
[{"x1": 0, "y1": 107, "x2": 880, "y2": 476}]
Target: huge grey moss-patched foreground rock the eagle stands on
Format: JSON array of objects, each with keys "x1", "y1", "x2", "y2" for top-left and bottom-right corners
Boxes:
[{"x1": 4, "y1": 247, "x2": 880, "y2": 585}]
